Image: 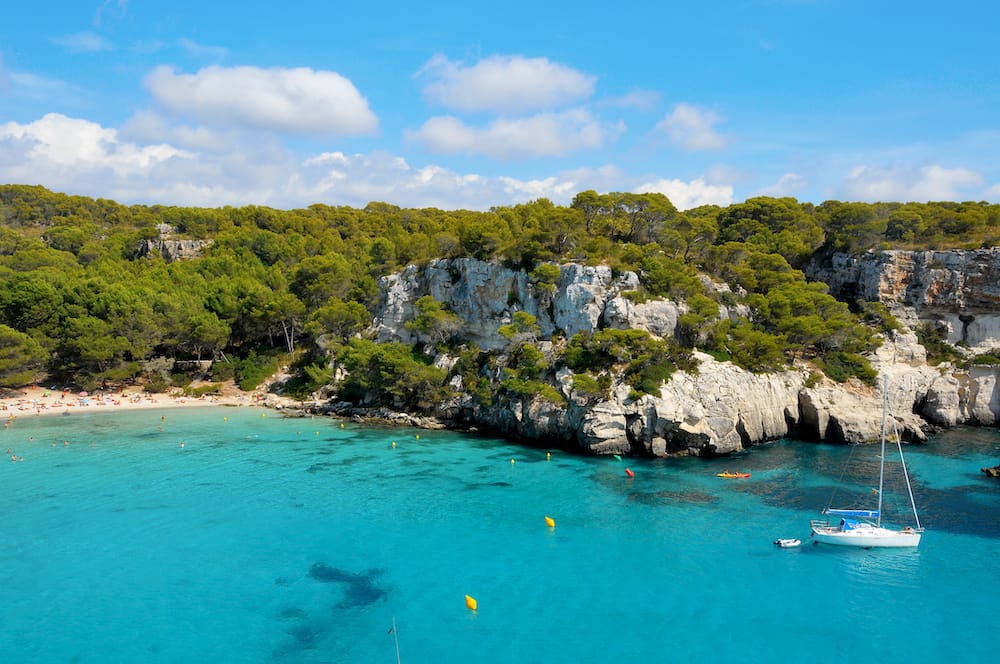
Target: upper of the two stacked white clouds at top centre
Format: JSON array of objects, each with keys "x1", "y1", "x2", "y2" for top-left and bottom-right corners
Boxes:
[{"x1": 417, "y1": 55, "x2": 596, "y2": 113}]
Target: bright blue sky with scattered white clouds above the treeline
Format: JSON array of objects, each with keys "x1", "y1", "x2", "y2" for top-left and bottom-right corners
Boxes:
[{"x1": 0, "y1": 0, "x2": 1000, "y2": 209}]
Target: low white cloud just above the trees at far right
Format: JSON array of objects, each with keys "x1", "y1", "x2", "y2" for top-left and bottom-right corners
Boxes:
[{"x1": 841, "y1": 164, "x2": 983, "y2": 202}]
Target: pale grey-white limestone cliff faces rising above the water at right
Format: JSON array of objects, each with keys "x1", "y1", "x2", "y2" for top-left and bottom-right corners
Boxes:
[{"x1": 373, "y1": 255, "x2": 1000, "y2": 456}]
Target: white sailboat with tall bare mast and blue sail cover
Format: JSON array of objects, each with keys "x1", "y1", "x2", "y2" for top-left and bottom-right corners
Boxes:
[{"x1": 809, "y1": 378, "x2": 924, "y2": 548}]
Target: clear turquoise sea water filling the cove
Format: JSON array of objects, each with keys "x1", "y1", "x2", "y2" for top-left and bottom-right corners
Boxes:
[{"x1": 0, "y1": 408, "x2": 1000, "y2": 664}]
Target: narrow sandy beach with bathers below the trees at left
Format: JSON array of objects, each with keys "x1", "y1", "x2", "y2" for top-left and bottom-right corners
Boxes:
[{"x1": 0, "y1": 386, "x2": 294, "y2": 419}]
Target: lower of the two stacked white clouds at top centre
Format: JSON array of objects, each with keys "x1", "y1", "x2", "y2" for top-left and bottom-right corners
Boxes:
[{"x1": 407, "y1": 109, "x2": 623, "y2": 159}]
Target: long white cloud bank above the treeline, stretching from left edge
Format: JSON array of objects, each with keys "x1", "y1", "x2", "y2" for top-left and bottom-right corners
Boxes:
[{"x1": 0, "y1": 113, "x2": 600, "y2": 210}]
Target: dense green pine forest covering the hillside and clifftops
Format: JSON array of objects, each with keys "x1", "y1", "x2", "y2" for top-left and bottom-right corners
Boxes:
[{"x1": 0, "y1": 185, "x2": 1000, "y2": 410}]
